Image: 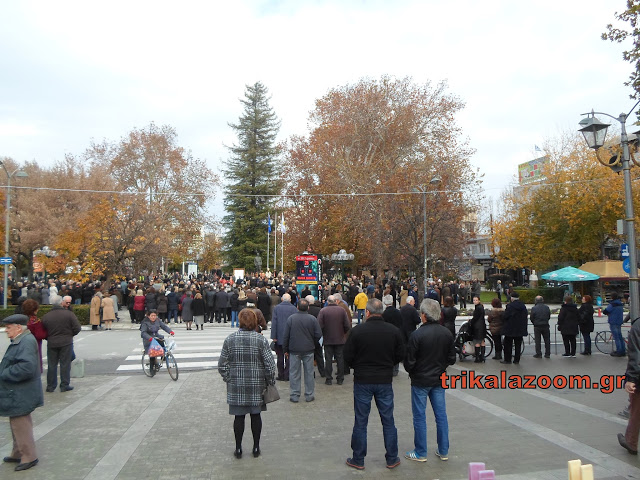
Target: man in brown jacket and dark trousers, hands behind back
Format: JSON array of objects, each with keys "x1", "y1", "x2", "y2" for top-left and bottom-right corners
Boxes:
[{"x1": 318, "y1": 295, "x2": 351, "y2": 385}]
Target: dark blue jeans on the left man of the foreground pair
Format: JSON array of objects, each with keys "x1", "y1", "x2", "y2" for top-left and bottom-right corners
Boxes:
[{"x1": 351, "y1": 383, "x2": 398, "y2": 465}]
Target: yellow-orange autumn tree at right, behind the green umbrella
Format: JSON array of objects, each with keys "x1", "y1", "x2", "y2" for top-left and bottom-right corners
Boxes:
[{"x1": 493, "y1": 134, "x2": 640, "y2": 272}]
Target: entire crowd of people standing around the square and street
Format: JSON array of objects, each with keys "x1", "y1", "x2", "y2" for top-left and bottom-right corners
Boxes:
[{"x1": 5, "y1": 268, "x2": 640, "y2": 470}]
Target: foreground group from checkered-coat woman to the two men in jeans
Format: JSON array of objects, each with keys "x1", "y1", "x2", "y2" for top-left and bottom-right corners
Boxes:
[{"x1": 218, "y1": 292, "x2": 456, "y2": 470}]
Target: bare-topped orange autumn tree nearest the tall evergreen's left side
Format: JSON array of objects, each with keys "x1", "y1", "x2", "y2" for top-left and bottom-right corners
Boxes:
[{"x1": 71, "y1": 123, "x2": 218, "y2": 275}]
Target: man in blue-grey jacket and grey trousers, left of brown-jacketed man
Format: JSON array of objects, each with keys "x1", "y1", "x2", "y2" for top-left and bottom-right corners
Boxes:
[{"x1": 282, "y1": 299, "x2": 322, "y2": 403}]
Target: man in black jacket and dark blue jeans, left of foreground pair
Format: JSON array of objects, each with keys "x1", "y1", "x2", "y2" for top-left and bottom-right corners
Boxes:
[{"x1": 344, "y1": 298, "x2": 405, "y2": 470}]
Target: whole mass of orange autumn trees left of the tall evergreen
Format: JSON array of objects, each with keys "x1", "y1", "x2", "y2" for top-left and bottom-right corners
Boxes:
[{"x1": 1, "y1": 123, "x2": 218, "y2": 279}]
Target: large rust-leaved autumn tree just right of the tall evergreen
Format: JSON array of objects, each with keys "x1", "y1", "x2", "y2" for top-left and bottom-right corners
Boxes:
[{"x1": 284, "y1": 76, "x2": 481, "y2": 284}]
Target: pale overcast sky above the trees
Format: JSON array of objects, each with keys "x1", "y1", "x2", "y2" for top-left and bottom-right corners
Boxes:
[{"x1": 0, "y1": 0, "x2": 633, "y2": 214}]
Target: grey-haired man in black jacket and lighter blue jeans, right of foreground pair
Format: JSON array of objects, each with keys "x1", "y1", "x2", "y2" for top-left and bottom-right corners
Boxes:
[{"x1": 404, "y1": 298, "x2": 456, "y2": 462}]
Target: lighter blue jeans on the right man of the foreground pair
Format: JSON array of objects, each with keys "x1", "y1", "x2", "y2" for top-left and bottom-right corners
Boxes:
[{"x1": 411, "y1": 385, "x2": 449, "y2": 457}]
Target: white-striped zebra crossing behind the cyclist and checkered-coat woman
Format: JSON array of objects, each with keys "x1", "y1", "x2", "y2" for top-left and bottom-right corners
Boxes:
[{"x1": 116, "y1": 323, "x2": 275, "y2": 373}]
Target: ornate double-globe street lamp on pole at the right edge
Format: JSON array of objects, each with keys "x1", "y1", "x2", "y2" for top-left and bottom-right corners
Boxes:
[{"x1": 579, "y1": 101, "x2": 640, "y2": 319}]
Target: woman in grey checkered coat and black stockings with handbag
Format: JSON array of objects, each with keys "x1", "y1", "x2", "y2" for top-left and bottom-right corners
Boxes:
[{"x1": 218, "y1": 308, "x2": 276, "y2": 458}]
